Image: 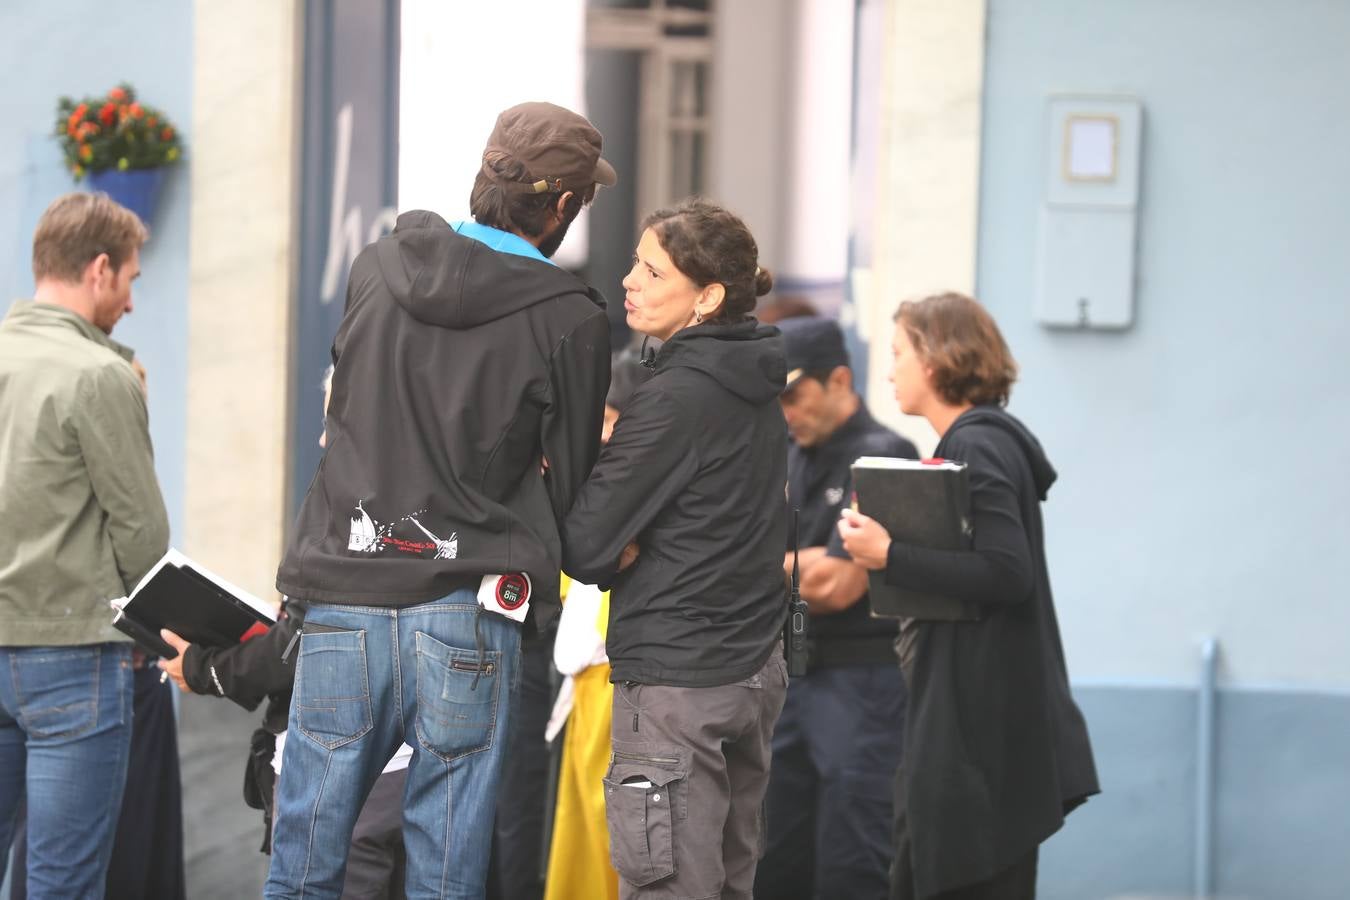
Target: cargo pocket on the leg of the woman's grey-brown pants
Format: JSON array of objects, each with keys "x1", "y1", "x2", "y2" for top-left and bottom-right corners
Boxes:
[{"x1": 605, "y1": 745, "x2": 689, "y2": 888}]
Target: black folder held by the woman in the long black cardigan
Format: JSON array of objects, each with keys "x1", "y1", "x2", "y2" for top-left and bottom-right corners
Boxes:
[{"x1": 852, "y1": 456, "x2": 980, "y2": 622}]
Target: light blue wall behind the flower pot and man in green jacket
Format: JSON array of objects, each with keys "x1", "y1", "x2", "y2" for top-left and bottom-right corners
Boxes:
[{"x1": 0, "y1": 0, "x2": 195, "y2": 540}]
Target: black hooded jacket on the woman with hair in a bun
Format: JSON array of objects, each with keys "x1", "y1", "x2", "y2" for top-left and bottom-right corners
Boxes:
[{"x1": 563, "y1": 320, "x2": 787, "y2": 687}]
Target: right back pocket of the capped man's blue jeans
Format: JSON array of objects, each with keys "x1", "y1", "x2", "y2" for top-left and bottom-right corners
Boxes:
[{"x1": 417, "y1": 631, "x2": 501, "y2": 761}]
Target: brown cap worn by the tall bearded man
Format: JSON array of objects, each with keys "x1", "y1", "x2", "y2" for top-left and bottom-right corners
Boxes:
[{"x1": 483, "y1": 103, "x2": 618, "y2": 194}]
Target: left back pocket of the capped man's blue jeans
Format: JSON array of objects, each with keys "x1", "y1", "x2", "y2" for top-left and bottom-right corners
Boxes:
[{"x1": 296, "y1": 623, "x2": 374, "y2": 750}]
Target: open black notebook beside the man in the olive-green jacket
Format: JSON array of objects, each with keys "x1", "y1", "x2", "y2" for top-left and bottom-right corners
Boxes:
[{"x1": 112, "y1": 549, "x2": 277, "y2": 660}]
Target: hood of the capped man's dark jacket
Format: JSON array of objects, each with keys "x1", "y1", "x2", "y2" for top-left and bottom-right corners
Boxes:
[{"x1": 375, "y1": 209, "x2": 605, "y2": 331}]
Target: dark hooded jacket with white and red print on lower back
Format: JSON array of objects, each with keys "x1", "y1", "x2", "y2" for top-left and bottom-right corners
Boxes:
[{"x1": 277, "y1": 210, "x2": 609, "y2": 625}]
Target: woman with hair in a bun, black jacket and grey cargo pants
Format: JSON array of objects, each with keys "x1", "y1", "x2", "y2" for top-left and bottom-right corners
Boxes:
[{"x1": 563, "y1": 201, "x2": 787, "y2": 899}]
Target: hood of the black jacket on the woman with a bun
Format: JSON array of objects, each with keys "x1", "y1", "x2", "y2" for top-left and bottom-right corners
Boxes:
[{"x1": 653, "y1": 318, "x2": 787, "y2": 403}]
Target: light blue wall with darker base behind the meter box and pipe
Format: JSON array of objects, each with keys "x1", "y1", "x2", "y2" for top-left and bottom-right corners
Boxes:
[{"x1": 977, "y1": 0, "x2": 1350, "y2": 900}]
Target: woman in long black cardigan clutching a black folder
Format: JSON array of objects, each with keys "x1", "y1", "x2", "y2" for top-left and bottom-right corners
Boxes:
[{"x1": 840, "y1": 294, "x2": 1099, "y2": 900}]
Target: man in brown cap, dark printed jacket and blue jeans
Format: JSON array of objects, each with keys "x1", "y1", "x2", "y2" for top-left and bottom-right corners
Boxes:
[{"x1": 265, "y1": 103, "x2": 616, "y2": 897}]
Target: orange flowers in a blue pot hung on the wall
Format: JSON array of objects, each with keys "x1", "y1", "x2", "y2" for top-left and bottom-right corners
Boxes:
[{"x1": 55, "y1": 84, "x2": 182, "y2": 223}]
